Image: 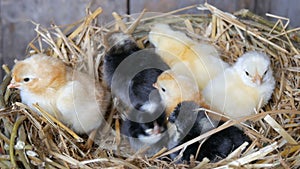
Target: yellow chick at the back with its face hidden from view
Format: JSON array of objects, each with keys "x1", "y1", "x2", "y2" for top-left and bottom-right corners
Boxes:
[{"x1": 149, "y1": 24, "x2": 229, "y2": 90}]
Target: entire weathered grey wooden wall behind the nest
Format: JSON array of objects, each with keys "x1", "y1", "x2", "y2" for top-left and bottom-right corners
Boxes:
[{"x1": 0, "y1": 0, "x2": 300, "y2": 79}]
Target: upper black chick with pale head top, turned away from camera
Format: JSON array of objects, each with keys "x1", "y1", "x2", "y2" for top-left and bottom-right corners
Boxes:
[{"x1": 104, "y1": 32, "x2": 169, "y2": 112}]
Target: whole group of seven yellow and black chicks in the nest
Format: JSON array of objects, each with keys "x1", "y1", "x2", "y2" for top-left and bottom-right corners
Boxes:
[{"x1": 9, "y1": 24, "x2": 275, "y2": 162}]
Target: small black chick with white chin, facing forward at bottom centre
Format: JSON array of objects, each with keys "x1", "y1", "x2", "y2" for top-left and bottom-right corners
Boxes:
[{"x1": 121, "y1": 109, "x2": 169, "y2": 156}]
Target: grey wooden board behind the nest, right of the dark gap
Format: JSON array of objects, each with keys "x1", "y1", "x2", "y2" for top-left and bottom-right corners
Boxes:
[{"x1": 130, "y1": 0, "x2": 300, "y2": 27}]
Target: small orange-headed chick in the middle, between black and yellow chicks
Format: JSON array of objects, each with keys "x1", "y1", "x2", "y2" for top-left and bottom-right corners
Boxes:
[{"x1": 153, "y1": 70, "x2": 205, "y2": 117}]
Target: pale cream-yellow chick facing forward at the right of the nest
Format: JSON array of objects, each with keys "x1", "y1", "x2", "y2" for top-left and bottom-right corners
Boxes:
[{"x1": 203, "y1": 51, "x2": 275, "y2": 119}]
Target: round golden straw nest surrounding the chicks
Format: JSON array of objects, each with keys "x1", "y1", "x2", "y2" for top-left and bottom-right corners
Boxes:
[{"x1": 0, "y1": 4, "x2": 300, "y2": 168}]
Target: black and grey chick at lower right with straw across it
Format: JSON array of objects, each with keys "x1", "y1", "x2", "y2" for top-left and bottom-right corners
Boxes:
[{"x1": 169, "y1": 101, "x2": 251, "y2": 162}]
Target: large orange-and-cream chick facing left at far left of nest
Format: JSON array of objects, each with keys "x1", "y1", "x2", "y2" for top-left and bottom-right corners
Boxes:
[{"x1": 8, "y1": 54, "x2": 110, "y2": 134}]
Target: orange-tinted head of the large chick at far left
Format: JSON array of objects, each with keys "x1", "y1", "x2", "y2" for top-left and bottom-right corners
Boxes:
[{"x1": 8, "y1": 54, "x2": 66, "y2": 94}]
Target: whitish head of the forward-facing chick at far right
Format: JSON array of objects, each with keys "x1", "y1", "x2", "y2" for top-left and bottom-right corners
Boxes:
[{"x1": 234, "y1": 51, "x2": 273, "y2": 87}]
